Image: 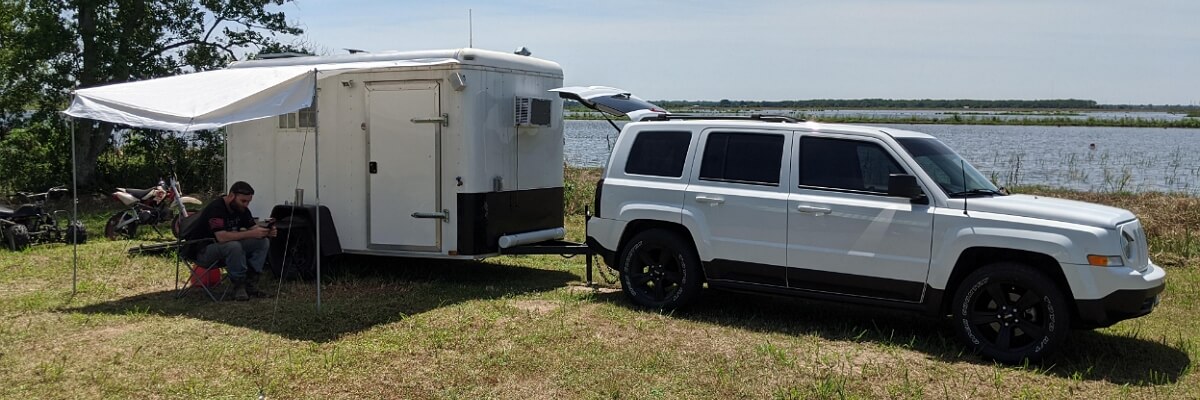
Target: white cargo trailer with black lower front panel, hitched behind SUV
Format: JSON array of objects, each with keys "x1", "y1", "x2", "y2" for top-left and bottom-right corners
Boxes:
[{"x1": 226, "y1": 49, "x2": 576, "y2": 269}]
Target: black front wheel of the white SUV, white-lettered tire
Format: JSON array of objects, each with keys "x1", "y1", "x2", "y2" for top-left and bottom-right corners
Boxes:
[{"x1": 953, "y1": 262, "x2": 1070, "y2": 364}]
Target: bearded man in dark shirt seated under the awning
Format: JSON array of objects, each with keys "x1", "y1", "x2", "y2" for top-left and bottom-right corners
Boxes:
[{"x1": 186, "y1": 180, "x2": 276, "y2": 302}]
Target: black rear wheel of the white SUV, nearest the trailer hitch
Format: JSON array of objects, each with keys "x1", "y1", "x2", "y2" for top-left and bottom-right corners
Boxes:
[{"x1": 618, "y1": 229, "x2": 702, "y2": 310}]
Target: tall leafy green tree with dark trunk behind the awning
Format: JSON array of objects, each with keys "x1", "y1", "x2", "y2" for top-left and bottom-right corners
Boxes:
[{"x1": 0, "y1": 0, "x2": 302, "y2": 186}]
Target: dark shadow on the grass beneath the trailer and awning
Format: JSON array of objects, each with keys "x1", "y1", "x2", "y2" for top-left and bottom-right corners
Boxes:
[{"x1": 62, "y1": 256, "x2": 576, "y2": 342}]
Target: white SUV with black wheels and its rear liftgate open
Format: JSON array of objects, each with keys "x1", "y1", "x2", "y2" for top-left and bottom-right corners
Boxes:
[{"x1": 559, "y1": 86, "x2": 1165, "y2": 363}]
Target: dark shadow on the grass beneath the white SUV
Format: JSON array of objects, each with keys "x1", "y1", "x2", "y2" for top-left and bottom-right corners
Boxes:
[{"x1": 585, "y1": 284, "x2": 1192, "y2": 386}]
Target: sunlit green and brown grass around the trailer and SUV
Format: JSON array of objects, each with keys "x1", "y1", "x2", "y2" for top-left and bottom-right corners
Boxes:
[{"x1": 0, "y1": 169, "x2": 1200, "y2": 399}]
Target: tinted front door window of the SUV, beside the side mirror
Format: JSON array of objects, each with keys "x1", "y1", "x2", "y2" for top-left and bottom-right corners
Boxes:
[{"x1": 799, "y1": 137, "x2": 906, "y2": 193}]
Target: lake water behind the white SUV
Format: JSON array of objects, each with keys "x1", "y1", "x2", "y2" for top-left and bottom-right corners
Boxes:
[{"x1": 564, "y1": 120, "x2": 1200, "y2": 195}]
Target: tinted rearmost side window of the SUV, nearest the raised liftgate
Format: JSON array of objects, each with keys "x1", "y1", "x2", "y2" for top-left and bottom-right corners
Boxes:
[{"x1": 625, "y1": 131, "x2": 691, "y2": 178}]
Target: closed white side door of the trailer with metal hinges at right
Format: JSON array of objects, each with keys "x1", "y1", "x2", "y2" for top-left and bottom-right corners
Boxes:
[{"x1": 366, "y1": 82, "x2": 445, "y2": 251}]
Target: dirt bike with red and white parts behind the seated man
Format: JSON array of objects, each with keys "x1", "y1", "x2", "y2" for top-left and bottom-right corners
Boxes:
[{"x1": 104, "y1": 175, "x2": 202, "y2": 240}]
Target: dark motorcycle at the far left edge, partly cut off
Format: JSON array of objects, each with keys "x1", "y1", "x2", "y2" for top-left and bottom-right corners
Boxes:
[{"x1": 0, "y1": 186, "x2": 88, "y2": 251}]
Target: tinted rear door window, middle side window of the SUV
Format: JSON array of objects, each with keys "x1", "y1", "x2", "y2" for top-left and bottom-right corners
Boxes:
[{"x1": 700, "y1": 132, "x2": 784, "y2": 186}]
